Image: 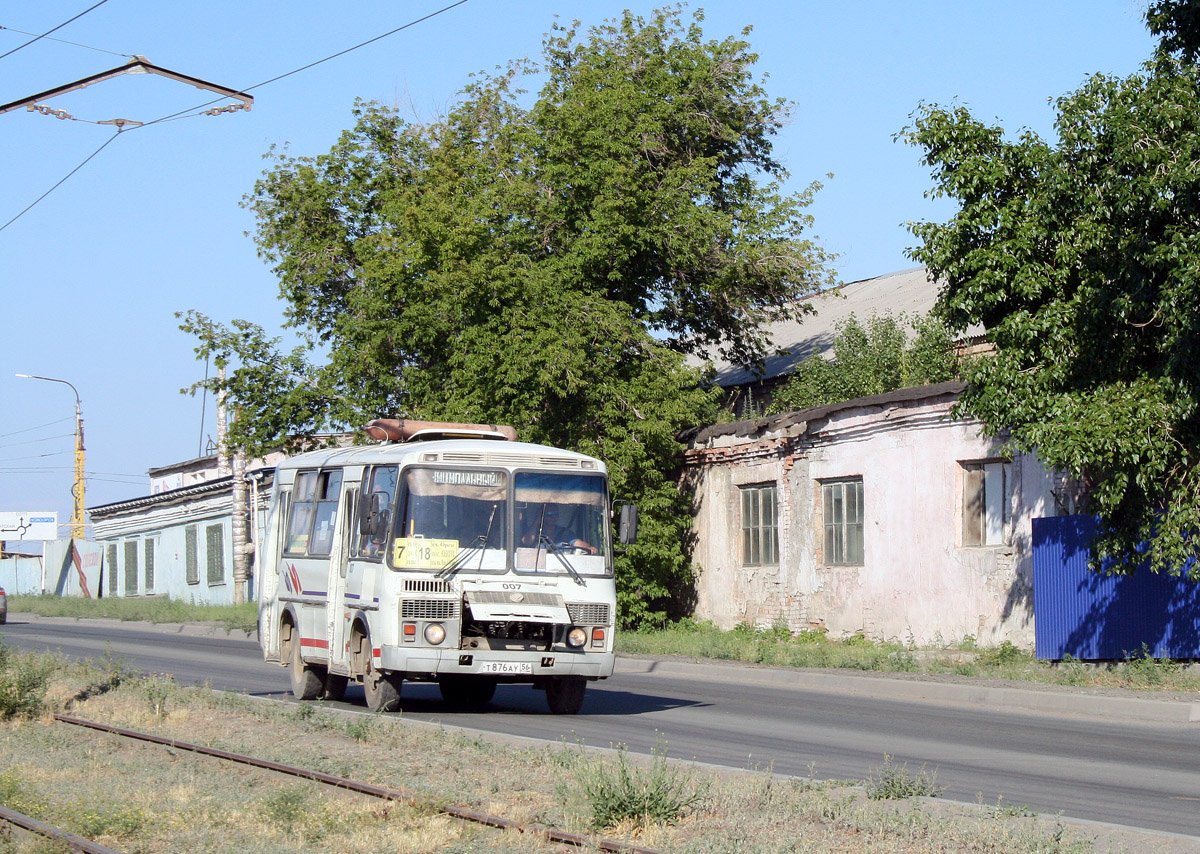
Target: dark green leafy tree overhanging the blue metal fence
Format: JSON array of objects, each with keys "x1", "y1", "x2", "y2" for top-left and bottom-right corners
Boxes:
[{"x1": 905, "y1": 1, "x2": 1200, "y2": 577}]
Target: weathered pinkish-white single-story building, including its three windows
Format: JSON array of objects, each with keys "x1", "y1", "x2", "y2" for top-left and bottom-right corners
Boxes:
[{"x1": 685, "y1": 383, "x2": 1069, "y2": 646}]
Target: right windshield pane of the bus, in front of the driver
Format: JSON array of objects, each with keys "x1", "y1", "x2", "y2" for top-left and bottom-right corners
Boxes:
[{"x1": 512, "y1": 471, "x2": 608, "y2": 575}]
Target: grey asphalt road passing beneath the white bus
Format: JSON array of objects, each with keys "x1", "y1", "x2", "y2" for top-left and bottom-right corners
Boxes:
[{"x1": 0, "y1": 614, "x2": 1200, "y2": 848}]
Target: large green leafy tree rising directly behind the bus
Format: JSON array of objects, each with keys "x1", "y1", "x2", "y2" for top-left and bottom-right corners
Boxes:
[{"x1": 184, "y1": 5, "x2": 829, "y2": 623}]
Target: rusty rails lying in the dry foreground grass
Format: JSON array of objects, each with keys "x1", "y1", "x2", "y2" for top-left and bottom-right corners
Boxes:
[{"x1": 0, "y1": 715, "x2": 661, "y2": 854}]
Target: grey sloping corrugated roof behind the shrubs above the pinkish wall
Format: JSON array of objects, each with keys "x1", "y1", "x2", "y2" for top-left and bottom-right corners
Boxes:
[{"x1": 713, "y1": 267, "x2": 937, "y2": 386}]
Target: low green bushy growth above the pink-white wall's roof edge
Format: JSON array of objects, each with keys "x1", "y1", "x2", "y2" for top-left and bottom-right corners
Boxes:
[{"x1": 767, "y1": 314, "x2": 958, "y2": 414}]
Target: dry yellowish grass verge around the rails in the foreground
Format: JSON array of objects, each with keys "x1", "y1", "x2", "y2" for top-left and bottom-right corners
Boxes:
[{"x1": 0, "y1": 647, "x2": 1152, "y2": 854}]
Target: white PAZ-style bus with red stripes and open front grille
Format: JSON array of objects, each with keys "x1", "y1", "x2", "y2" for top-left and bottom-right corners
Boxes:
[{"x1": 257, "y1": 419, "x2": 637, "y2": 715}]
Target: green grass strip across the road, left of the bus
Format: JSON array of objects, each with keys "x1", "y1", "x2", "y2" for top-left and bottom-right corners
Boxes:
[{"x1": 8, "y1": 594, "x2": 258, "y2": 632}]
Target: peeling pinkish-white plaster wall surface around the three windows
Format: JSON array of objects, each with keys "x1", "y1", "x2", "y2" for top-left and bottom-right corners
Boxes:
[{"x1": 689, "y1": 396, "x2": 1054, "y2": 646}]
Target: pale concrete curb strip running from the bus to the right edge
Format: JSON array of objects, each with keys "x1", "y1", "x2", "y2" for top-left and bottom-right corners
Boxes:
[{"x1": 617, "y1": 656, "x2": 1200, "y2": 723}]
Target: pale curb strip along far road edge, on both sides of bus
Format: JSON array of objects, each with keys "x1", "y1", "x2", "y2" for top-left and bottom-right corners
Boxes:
[{"x1": 16, "y1": 613, "x2": 1200, "y2": 723}]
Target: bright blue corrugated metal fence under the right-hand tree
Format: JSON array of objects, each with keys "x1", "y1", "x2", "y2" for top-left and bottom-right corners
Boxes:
[{"x1": 1033, "y1": 516, "x2": 1200, "y2": 661}]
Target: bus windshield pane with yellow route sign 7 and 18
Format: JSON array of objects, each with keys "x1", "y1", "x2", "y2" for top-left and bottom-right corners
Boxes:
[{"x1": 389, "y1": 468, "x2": 508, "y2": 572}]
